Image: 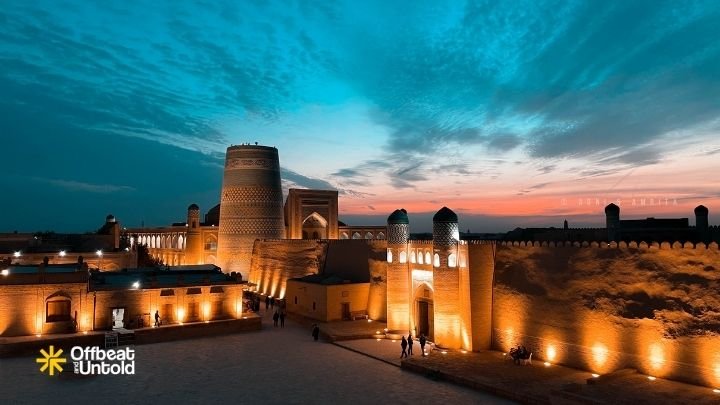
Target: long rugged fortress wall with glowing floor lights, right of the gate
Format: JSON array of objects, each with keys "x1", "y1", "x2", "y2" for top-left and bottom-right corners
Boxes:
[{"x1": 490, "y1": 242, "x2": 720, "y2": 387}]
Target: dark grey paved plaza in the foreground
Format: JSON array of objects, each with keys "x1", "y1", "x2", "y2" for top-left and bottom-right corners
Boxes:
[{"x1": 0, "y1": 316, "x2": 512, "y2": 404}]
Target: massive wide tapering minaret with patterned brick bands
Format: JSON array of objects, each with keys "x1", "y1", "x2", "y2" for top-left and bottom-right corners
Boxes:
[{"x1": 217, "y1": 145, "x2": 285, "y2": 279}]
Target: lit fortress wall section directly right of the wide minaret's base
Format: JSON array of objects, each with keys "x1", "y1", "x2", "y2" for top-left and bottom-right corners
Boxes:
[{"x1": 249, "y1": 239, "x2": 327, "y2": 298}]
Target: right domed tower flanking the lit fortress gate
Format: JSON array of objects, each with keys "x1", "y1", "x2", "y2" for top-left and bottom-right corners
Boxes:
[{"x1": 432, "y1": 207, "x2": 466, "y2": 349}]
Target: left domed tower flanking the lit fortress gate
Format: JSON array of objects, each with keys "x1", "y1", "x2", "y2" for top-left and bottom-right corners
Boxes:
[{"x1": 387, "y1": 209, "x2": 411, "y2": 335}]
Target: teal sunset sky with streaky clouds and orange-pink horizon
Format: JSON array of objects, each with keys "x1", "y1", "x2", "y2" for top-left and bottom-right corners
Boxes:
[{"x1": 0, "y1": 0, "x2": 720, "y2": 232}]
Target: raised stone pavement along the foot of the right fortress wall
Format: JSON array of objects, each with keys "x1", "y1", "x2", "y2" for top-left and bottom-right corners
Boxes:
[{"x1": 335, "y1": 339, "x2": 720, "y2": 405}]
